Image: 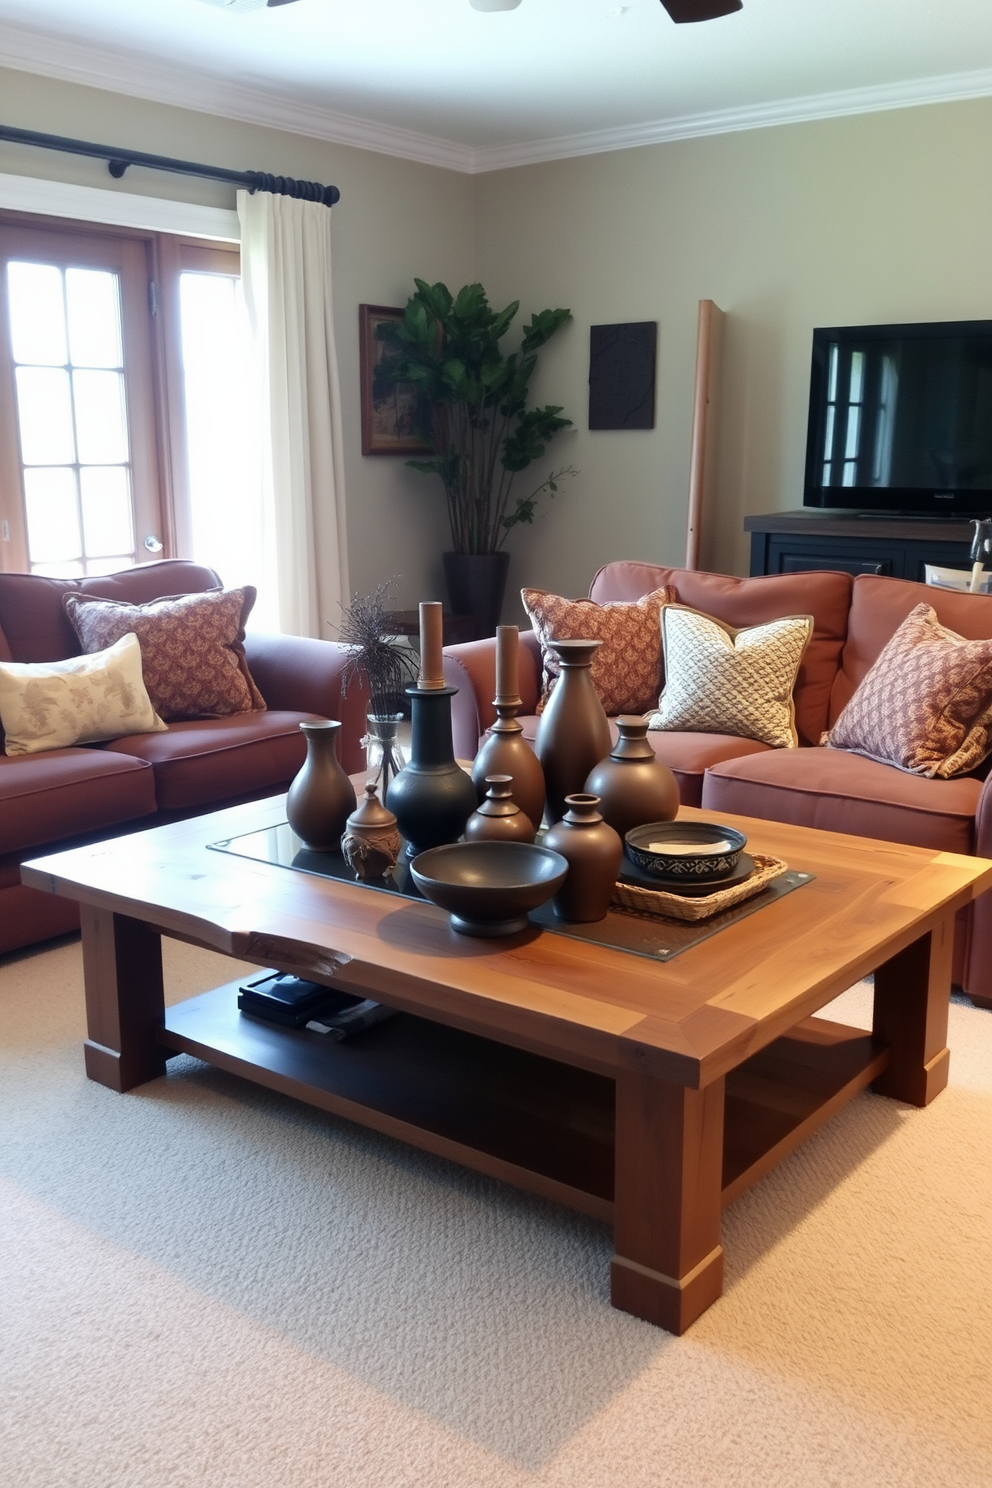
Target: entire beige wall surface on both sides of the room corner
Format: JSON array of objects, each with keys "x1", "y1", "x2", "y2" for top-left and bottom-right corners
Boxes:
[{"x1": 0, "y1": 71, "x2": 992, "y2": 619}]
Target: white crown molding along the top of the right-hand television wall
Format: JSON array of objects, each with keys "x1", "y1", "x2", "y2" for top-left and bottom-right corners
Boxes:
[{"x1": 473, "y1": 68, "x2": 992, "y2": 171}]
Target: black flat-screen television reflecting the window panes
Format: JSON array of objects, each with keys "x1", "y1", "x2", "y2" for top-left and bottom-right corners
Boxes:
[{"x1": 803, "y1": 320, "x2": 992, "y2": 518}]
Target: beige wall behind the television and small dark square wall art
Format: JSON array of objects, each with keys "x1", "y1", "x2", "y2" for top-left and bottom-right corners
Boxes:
[{"x1": 476, "y1": 100, "x2": 992, "y2": 594}]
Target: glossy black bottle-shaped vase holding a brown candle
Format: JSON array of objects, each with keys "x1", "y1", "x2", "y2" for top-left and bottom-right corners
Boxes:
[{"x1": 385, "y1": 687, "x2": 479, "y2": 857}]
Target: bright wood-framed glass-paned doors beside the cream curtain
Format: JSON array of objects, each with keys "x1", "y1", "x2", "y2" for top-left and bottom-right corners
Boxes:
[{"x1": 0, "y1": 217, "x2": 243, "y2": 582}]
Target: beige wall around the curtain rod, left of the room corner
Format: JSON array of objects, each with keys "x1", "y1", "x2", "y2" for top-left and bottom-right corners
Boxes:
[{"x1": 0, "y1": 70, "x2": 473, "y2": 606}]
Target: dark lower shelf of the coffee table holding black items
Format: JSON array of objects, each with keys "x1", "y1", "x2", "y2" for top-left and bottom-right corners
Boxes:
[{"x1": 158, "y1": 982, "x2": 888, "y2": 1222}]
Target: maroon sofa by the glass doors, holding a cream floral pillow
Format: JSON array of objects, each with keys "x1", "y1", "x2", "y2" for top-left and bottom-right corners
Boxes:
[{"x1": 0, "y1": 559, "x2": 366, "y2": 954}]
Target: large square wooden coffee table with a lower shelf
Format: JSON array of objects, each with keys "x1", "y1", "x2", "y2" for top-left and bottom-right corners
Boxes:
[{"x1": 22, "y1": 798, "x2": 992, "y2": 1333}]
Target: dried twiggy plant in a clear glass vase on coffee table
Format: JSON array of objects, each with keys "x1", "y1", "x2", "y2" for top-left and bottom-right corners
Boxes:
[{"x1": 338, "y1": 579, "x2": 416, "y2": 801}]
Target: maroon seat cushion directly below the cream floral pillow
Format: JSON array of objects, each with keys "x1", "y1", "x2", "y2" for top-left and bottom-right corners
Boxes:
[{"x1": 0, "y1": 749, "x2": 156, "y2": 853}]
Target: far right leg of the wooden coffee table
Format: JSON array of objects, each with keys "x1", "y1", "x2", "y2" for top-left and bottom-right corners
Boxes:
[{"x1": 872, "y1": 915, "x2": 955, "y2": 1106}]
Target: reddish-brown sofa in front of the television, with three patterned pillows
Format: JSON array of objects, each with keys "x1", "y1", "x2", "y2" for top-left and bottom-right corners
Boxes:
[{"x1": 445, "y1": 562, "x2": 992, "y2": 1007}]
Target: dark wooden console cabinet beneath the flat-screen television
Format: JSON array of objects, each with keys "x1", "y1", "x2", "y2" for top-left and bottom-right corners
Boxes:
[{"x1": 744, "y1": 510, "x2": 975, "y2": 583}]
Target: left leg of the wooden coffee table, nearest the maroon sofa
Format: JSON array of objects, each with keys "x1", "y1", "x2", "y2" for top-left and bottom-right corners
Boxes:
[{"x1": 80, "y1": 905, "x2": 165, "y2": 1091}]
